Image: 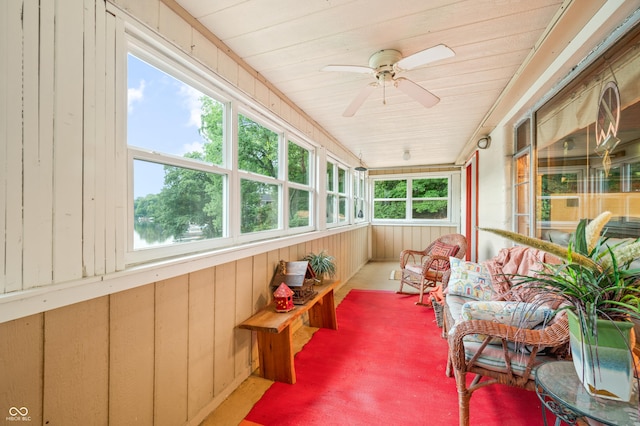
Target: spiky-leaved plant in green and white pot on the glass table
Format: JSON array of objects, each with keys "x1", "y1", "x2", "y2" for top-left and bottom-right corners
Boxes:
[{"x1": 480, "y1": 212, "x2": 640, "y2": 401}]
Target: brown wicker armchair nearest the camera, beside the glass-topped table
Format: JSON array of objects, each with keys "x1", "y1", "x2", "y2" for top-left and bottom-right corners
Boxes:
[{"x1": 443, "y1": 248, "x2": 569, "y2": 426}]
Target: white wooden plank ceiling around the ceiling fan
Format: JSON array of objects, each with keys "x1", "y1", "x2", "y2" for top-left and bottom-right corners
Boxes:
[{"x1": 171, "y1": 0, "x2": 636, "y2": 168}]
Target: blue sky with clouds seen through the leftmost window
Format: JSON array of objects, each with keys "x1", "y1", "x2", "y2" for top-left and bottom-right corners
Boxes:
[{"x1": 127, "y1": 55, "x2": 210, "y2": 198}]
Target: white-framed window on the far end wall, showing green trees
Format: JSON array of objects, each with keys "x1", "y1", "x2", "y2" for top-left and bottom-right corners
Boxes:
[{"x1": 373, "y1": 174, "x2": 458, "y2": 222}]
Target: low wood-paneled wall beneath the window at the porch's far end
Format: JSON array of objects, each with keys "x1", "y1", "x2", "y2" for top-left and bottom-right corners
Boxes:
[{"x1": 371, "y1": 225, "x2": 459, "y2": 260}]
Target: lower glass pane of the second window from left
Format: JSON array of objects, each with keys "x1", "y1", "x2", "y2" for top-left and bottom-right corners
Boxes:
[{"x1": 240, "y1": 179, "x2": 280, "y2": 234}]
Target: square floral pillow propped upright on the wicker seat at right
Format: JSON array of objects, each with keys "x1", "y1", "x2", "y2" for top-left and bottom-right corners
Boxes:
[{"x1": 446, "y1": 257, "x2": 495, "y2": 300}]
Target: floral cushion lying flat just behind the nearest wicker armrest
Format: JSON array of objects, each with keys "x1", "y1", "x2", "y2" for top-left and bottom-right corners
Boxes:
[{"x1": 460, "y1": 300, "x2": 554, "y2": 343}]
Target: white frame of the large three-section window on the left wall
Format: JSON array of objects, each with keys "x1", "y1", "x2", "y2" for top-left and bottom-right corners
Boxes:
[{"x1": 123, "y1": 33, "x2": 319, "y2": 265}]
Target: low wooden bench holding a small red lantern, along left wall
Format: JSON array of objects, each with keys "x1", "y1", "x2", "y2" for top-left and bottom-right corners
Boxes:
[{"x1": 238, "y1": 281, "x2": 339, "y2": 384}]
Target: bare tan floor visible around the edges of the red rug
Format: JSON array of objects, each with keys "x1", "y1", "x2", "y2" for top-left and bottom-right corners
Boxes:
[{"x1": 200, "y1": 261, "x2": 420, "y2": 426}]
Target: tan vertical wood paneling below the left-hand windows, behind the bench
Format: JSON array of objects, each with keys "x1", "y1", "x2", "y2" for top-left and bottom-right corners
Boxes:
[{"x1": 0, "y1": 227, "x2": 370, "y2": 426}]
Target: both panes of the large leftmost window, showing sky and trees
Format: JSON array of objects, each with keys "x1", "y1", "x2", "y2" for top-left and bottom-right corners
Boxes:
[{"x1": 127, "y1": 54, "x2": 228, "y2": 250}]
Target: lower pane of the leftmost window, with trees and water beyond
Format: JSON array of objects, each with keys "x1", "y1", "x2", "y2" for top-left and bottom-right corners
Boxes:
[{"x1": 133, "y1": 160, "x2": 225, "y2": 250}]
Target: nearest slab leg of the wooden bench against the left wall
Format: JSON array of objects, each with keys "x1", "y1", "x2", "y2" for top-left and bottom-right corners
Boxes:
[{"x1": 258, "y1": 326, "x2": 296, "y2": 384}]
